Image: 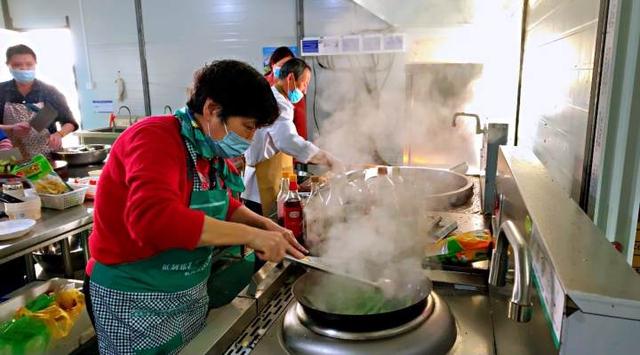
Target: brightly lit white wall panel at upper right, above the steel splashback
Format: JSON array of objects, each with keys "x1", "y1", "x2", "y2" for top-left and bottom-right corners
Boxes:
[{"x1": 518, "y1": 0, "x2": 600, "y2": 200}]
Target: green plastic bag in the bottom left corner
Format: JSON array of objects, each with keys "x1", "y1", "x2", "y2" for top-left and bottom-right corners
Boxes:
[{"x1": 0, "y1": 317, "x2": 51, "y2": 355}]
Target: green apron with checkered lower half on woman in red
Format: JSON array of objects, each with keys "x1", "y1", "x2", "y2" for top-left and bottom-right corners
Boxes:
[{"x1": 90, "y1": 109, "x2": 255, "y2": 354}]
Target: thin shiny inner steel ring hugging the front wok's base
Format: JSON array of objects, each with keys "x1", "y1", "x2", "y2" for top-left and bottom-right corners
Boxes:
[{"x1": 294, "y1": 296, "x2": 434, "y2": 340}]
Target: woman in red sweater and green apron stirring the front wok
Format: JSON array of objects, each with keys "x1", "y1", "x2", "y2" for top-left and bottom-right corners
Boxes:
[{"x1": 86, "y1": 60, "x2": 306, "y2": 354}]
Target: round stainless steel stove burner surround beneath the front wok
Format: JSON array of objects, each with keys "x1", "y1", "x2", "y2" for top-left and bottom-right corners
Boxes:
[{"x1": 282, "y1": 292, "x2": 457, "y2": 354}]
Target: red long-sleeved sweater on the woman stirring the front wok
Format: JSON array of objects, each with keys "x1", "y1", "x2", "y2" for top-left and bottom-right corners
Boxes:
[{"x1": 86, "y1": 116, "x2": 241, "y2": 274}]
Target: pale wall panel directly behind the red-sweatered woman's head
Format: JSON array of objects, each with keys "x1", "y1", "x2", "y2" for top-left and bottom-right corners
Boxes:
[{"x1": 142, "y1": 0, "x2": 296, "y2": 114}]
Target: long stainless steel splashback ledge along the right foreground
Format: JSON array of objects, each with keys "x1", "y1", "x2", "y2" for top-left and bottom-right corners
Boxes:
[{"x1": 495, "y1": 147, "x2": 640, "y2": 354}]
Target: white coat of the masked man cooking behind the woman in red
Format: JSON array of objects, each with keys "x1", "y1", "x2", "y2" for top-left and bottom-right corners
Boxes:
[{"x1": 241, "y1": 86, "x2": 320, "y2": 203}]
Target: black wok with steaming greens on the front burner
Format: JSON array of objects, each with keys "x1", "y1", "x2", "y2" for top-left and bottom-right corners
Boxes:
[{"x1": 293, "y1": 270, "x2": 431, "y2": 332}]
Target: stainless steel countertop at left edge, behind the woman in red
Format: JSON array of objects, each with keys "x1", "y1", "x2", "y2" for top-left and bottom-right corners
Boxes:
[{"x1": 0, "y1": 202, "x2": 93, "y2": 264}]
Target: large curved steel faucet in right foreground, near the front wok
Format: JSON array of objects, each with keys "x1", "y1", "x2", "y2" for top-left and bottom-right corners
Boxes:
[{"x1": 489, "y1": 220, "x2": 533, "y2": 323}]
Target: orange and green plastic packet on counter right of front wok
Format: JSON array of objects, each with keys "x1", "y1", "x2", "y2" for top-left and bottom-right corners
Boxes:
[{"x1": 427, "y1": 230, "x2": 493, "y2": 264}]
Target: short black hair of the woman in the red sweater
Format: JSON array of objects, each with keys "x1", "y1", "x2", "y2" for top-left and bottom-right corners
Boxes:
[{"x1": 187, "y1": 60, "x2": 280, "y2": 127}]
